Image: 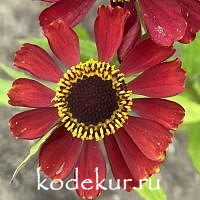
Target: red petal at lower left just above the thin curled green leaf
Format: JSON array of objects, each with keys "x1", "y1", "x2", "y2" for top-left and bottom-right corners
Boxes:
[{"x1": 9, "y1": 108, "x2": 59, "y2": 140}]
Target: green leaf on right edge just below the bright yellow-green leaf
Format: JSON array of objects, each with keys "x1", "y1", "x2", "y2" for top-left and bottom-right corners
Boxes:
[{"x1": 188, "y1": 122, "x2": 200, "y2": 172}]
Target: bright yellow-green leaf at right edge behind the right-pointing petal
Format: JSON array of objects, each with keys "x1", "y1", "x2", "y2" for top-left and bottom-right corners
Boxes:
[{"x1": 169, "y1": 95, "x2": 200, "y2": 123}]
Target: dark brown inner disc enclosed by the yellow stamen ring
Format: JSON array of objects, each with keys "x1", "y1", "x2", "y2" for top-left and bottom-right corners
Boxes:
[{"x1": 67, "y1": 75, "x2": 118, "y2": 125}]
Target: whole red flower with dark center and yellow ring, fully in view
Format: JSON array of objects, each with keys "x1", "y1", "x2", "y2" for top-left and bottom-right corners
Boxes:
[{"x1": 8, "y1": 6, "x2": 185, "y2": 199}]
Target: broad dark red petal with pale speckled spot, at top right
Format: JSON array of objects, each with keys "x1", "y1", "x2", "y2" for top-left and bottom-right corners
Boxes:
[{"x1": 139, "y1": 0, "x2": 187, "y2": 46}]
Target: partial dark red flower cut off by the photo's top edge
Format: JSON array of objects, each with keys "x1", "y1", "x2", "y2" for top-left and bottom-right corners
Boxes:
[{"x1": 40, "y1": 0, "x2": 200, "y2": 46}]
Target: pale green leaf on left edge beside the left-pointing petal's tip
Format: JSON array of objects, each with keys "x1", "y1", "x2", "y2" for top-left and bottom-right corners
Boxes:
[{"x1": 0, "y1": 78, "x2": 12, "y2": 106}]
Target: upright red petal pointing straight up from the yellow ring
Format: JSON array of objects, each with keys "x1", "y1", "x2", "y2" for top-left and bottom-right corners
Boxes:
[{"x1": 94, "y1": 6, "x2": 129, "y2": 62}]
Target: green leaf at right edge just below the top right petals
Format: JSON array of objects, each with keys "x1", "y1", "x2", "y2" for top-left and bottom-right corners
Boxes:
[{"x1": 179, "y1": 33, "x2": 200, "y2": 76}]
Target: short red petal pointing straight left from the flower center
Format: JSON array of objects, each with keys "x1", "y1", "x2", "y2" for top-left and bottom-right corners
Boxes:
[{"x1": 8, "y1": 78, "x2": 55, "y2": 108}]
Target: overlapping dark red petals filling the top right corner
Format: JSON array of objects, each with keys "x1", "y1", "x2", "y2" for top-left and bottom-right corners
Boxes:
[{"x1": 111, "y1": 0, "x2": 200, "y2": 46}]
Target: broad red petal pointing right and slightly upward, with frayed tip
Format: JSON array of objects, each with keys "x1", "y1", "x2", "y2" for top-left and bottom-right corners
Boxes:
[{"x1": 128, "y1": 60, "x2": 186, "y2": 98}]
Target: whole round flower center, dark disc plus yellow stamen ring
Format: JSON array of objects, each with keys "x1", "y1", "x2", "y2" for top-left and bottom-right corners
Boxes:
[{"x1": 54, "y1": 59, "x2": 132, "y2": 141}]
